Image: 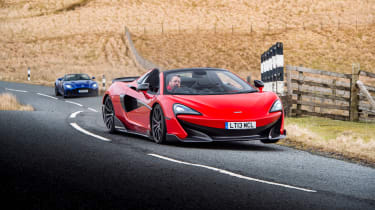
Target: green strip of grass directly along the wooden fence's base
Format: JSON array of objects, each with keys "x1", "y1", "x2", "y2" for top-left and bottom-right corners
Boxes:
[{"x1": 285, "y1": 117, "x2": 375, "y2": 143}]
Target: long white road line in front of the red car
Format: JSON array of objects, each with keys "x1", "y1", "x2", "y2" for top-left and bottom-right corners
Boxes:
[{"x1": 148, "y1": 154, "x2": 317, "y2": 192}]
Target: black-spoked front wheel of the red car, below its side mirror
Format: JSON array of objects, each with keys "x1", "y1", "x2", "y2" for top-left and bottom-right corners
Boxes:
[{"x1": 151, "y1": 104, "x2": 167, "y2": 144}]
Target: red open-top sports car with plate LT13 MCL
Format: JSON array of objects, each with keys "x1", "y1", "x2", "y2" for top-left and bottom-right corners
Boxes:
[{"x1": 102, "y1": 68, "x2": 286, "y2": 143}]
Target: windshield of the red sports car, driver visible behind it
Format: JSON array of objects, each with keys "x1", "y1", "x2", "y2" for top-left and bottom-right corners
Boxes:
[{"x1": 164, "y1": 69, "x2": 256, "y2": 95}]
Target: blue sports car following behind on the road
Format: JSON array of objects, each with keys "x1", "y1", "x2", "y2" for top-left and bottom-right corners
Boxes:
[{"x1": 55, "y1": 74, "x2": 99, "y2": 98}]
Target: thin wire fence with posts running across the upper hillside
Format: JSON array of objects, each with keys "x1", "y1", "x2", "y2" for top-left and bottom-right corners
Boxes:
[{"x1": 126, "y1": 15, "x2": 375, "y2": 35}]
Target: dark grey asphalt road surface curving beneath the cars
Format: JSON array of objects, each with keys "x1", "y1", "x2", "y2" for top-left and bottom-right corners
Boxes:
[{"x1": 0, "y1": 82, "x2": 375, "y2": 209}]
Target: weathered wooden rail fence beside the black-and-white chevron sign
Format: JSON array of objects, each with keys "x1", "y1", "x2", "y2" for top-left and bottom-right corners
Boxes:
[{"x1": 282, "y1": 66, "x2": 375, "y2": 121}]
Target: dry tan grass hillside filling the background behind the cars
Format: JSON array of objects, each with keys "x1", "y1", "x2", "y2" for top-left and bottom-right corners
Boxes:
[{"x1": 0, "y1": 0, "x2": 375, "y2": 85}]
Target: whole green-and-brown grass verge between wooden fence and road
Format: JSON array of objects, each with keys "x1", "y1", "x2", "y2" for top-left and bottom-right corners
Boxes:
[{"x1": 280, "y1": 117, "x2": 375, "y2": 167}]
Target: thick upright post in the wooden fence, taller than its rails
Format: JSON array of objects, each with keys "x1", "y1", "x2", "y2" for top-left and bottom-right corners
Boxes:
[{"x1": 349, "y1": 64, "x2": 359, "y2": 121}]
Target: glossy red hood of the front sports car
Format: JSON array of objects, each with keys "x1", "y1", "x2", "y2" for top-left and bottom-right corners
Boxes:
[{"x1": 173, "y1": 92, "x2": 278, "y2": 119}]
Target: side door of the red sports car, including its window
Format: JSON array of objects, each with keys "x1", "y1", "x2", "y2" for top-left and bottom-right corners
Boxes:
[{"x1": 123, "y1": 69, "x2": 160, "y2": 133}]
